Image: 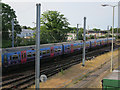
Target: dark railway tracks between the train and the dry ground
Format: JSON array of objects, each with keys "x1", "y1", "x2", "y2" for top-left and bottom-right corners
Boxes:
[{"x1": 2, "y1": 44, "x2": 119, "y2": 90}]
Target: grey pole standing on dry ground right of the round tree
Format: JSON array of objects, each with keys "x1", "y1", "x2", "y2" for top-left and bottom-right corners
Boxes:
[{"x1": 82, "y1": 17, "x2": 86, "y2": 66}]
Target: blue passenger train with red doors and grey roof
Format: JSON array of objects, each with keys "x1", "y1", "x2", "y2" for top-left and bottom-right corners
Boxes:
[{"x1": 2, "y1": 38, "x2": 115, "y2": 68}]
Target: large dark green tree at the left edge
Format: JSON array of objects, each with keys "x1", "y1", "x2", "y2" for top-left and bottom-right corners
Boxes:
[{"x1": 2, "y1": 3, "x2": 21, "y2": 40}]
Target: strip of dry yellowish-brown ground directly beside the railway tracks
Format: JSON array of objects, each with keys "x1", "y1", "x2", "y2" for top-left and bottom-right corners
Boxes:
[{"x1": 30, "y1": 50, "x2": 118, "y2": 88}]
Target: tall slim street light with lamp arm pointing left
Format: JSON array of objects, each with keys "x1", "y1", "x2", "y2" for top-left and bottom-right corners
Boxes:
[{"x1": 102, "y1": 4, "x2": 117, "y2": 72}]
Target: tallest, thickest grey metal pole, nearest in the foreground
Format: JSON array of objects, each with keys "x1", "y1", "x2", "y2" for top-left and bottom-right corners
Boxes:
[{"x1": 35, "y1": 4, "x2": 41, "y2": 90}]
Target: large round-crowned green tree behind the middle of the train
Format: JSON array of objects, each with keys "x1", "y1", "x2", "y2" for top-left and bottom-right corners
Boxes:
[{"x1": 41, "y1": 11, "x2": 69, "y2": 42}]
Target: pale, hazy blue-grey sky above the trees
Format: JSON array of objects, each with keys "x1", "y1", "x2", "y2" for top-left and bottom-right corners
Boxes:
[{"x1": 3, "y1": 0, "x2": 118, "y2": 30}]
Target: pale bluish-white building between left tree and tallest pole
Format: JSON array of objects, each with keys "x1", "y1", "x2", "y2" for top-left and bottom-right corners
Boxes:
[{"x1": 17, "y1": 29, "x2": 35, "y2": 38}]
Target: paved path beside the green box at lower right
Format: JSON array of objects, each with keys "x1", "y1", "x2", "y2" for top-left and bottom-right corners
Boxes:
[{"x1": 69, "y1": 57, "x2": 118, "y2": 88}]
